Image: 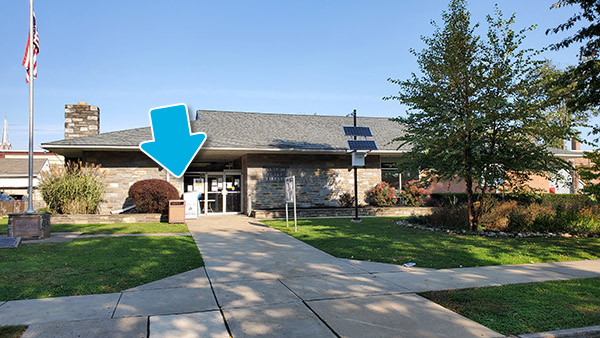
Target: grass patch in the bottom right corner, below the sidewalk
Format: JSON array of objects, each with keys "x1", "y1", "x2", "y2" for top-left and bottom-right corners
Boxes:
[{"x1": 422, "y1": 278, "x2": 600, "y2": 335}]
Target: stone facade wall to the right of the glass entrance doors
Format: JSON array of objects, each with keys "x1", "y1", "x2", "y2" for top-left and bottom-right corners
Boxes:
[{"x1": 242, "y1": 154, "x2": 381, "y2": 213}]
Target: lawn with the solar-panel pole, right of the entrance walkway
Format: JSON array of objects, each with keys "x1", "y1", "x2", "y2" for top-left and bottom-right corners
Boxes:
[{"x1": 264, "y1": 217, "x2": 600, "y2": 269}]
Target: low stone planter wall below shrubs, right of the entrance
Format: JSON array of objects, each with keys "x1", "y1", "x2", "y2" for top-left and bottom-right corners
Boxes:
[{"x1": 252, "y1": 207, "x2": 435, "y2": 220}]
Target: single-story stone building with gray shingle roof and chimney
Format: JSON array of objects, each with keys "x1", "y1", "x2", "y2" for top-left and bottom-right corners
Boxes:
[{"x1": 42, "y1": 102, "x2": 592, "y2": 214}]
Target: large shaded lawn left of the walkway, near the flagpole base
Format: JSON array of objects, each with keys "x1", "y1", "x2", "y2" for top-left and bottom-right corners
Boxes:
[{"x1": 0, "y1": 236, "x2": 204, "y2": 300}]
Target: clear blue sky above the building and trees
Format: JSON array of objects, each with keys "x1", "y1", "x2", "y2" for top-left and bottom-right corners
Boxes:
[{"x1": 0, "y1": 0, "x2": 598, "y2": 149}]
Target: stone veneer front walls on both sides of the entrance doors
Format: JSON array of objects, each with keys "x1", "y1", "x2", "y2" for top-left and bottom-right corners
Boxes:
[{"x1": 82, "y1": 151, "x2": 381, "y2": 214}]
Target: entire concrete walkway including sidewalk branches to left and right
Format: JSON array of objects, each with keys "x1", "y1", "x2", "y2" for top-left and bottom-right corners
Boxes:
[{"x1": 0, "y1": 215, "x2": 600, "y2": 337}]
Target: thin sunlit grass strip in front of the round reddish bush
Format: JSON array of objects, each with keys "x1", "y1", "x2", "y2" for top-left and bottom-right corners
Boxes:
[{"x1": 0, "y1": 218, "x2": 190, "y2": 235}]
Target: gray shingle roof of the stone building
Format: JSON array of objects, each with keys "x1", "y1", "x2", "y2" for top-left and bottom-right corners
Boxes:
[{"x1": 42, "y1": 110, "x2": 403, "y2": 151}]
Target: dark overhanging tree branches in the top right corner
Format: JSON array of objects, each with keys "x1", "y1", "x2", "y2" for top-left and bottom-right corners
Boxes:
[{"x1": 546, "y1": 0, "x2": 600, "y2": 111}]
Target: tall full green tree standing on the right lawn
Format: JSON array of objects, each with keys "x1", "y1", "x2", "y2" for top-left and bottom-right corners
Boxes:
[{"x1": 384, "y1": 0, "x2": 569, "y2": 231}]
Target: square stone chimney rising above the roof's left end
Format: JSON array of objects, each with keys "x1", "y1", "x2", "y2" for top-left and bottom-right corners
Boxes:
[{"x1": 65, "y1": 102, "x2": 100, "y2": 139}]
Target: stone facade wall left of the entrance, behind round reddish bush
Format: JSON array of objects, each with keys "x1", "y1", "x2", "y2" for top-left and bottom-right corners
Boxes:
[{"x1": 82, "y1": 151, "x2": 171, "y2": 214}]
